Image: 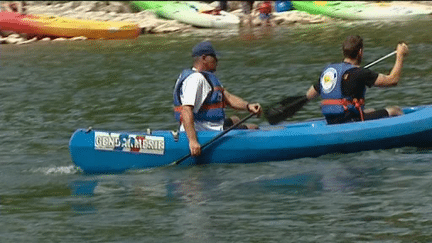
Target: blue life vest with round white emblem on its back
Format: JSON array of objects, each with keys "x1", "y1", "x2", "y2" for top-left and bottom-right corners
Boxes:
[{"x1": 320, "y1": 62, "x2": 366, "y2": 121}]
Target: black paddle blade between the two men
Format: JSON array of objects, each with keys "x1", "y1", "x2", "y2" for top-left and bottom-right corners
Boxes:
[{"x1": 264, "y1": 95, "x2": 308, "y2": 125}]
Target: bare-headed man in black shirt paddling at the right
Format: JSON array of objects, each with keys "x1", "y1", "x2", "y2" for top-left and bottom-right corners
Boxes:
[{"x1": 306, "y1": 36, "x2": 408, "y2": 124}]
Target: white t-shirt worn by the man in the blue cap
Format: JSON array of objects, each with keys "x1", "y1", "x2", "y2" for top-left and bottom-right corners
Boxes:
[{"x1": 180, "y1": 68, "x2": 224, "y2": 131}]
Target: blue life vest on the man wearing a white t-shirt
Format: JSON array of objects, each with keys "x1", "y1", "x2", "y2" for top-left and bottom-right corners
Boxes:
[{"x1": 173, "y1": 69, "x2": 226, "y2": 122}]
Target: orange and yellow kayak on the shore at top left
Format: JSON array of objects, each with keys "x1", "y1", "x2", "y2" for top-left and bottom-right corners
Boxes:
[{"x1": 0, "y1": 12, "x2": 140, "y2": 39}]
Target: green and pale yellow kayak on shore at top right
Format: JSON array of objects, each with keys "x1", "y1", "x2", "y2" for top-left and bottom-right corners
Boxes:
[{"x1": 292, "y1": 1, "x2": 431, "y2": 20}]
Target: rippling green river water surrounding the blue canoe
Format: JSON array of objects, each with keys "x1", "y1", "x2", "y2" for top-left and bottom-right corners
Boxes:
[{"x1": 0, "y1": 21, "x2": 432, "y2": 242}]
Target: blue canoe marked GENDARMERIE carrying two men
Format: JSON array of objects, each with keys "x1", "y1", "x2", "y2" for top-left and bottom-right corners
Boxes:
[{"x1": 69, "y1": 105, "x2": 432, "y2": 173}]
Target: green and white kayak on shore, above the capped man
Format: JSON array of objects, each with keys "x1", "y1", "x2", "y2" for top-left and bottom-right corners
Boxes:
[{"x1": 131, "y1": 1, "x2": 240, "y2": 28}]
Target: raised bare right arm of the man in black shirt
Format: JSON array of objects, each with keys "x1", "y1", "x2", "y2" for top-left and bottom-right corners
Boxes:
[{"x1": 374, "y1": 43, "x2": 408, "y2": 87}]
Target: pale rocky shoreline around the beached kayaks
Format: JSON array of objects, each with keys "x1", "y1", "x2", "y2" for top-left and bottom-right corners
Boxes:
[{"x1": 0, "y1": 1, "x2": 431, "y2": 45}]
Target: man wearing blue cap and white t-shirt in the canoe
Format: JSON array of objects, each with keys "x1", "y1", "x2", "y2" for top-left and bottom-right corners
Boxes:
[{"x1": 173, "y1": 41, "x2": 262, "y2": 156}]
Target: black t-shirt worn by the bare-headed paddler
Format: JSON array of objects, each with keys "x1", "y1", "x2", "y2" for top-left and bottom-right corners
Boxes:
[{"x1": 314, "y1": 67, "x2": 378, "y2": 99}]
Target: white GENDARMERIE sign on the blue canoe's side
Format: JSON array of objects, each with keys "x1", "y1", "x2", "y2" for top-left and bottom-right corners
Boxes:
[{"x1": 94, "y1": 132, "x2": 165, "y2": 154}]
